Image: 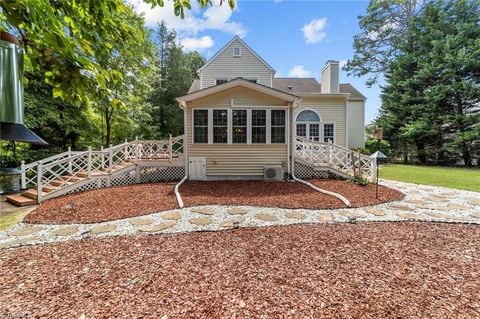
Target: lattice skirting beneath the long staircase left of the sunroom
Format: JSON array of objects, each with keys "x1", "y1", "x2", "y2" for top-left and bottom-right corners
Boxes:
[{"x1": 67, "y1": 166, "x2": 185, "y2": 194}]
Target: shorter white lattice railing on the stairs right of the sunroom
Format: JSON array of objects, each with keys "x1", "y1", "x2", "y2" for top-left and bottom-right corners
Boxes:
[{"x1": 295, "y1": 136, "x2": 376, "y2": 182}]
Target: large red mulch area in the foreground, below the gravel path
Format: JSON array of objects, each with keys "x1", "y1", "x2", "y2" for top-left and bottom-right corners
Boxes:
[{"x1": 0, "y1": 222, "x2": 480, "y2": 318}]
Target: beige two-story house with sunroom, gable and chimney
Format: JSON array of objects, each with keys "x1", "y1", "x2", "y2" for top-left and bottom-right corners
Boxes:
[{"x1": 177, "y1": 37, "x2": 365, "y2": 180}]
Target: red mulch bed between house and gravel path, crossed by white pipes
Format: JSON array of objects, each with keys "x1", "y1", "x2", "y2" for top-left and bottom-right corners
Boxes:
[{"x1": 24, "y1": 180, "x2": 403, "y2": 224}]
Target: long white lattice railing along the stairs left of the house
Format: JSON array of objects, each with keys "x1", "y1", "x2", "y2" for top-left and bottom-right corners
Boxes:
[{"x1": 21, "y1": 135, "x2": 183, "y2": 202}]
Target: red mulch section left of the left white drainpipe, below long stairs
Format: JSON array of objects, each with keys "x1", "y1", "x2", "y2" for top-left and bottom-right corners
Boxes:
[{"x1": 24, "y1": 183, "x2": 178, "y2": 224}]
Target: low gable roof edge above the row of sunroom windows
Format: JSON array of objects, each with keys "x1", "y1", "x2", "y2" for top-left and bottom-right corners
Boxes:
[{"x1": 177, "y1": 78, "x2": 301, "y2": 106}]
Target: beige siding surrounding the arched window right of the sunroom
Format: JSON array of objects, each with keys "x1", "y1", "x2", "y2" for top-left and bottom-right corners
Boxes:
[{"x1": 292, "y1": 97, "x2": 346, "y2": 147}]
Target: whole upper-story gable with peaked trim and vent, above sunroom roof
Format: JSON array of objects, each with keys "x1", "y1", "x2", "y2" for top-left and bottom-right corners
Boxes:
[{"x1": 198, "y1": 36, "x2": 276, "y2": 89}]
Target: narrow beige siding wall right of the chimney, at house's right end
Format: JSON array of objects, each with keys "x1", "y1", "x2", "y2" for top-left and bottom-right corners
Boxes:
[{"x1": 347, "y1": 101, "x2": 365, "y2": 148}]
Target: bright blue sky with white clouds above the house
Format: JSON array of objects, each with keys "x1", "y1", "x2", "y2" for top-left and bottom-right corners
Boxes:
[{"x1": 129, "y1": 0, "x2": 380, "y2": 124}]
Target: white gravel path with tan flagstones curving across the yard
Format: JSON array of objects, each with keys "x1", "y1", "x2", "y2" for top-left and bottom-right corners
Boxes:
[{"x1": 0, "y1": 181, "x2": 480, "y2": 248}]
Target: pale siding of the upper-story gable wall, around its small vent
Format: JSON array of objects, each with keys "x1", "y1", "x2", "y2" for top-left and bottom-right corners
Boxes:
[{"x1": 200, "y1": 40, "x2": 273, "y2": 89}]
